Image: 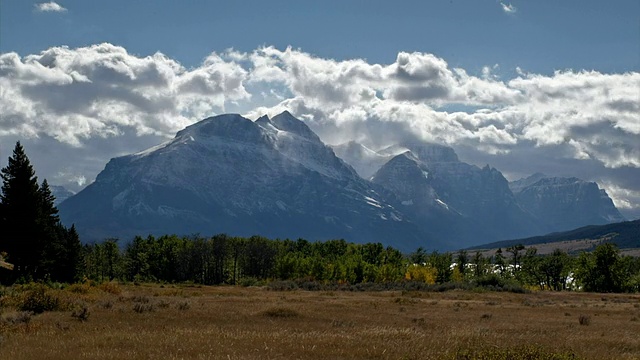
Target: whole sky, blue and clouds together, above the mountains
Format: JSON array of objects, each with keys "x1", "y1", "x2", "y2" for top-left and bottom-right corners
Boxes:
[{"x1": 0, "y1": 0, "x2": 640, "y2": 219}]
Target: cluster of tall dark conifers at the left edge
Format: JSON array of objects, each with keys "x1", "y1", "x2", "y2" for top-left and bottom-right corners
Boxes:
[{"x1": 0, "y1": 142, "x2": 82, "y2": 282}]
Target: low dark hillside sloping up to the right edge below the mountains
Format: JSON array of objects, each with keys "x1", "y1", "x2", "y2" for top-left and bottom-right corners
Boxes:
[{"x1": 472, "y1": 220, "x2": 640, "y2": 249}]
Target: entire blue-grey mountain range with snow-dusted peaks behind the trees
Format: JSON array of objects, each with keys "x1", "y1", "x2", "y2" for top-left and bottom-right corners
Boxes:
[{"x1": 59, "y1": 112, "x2": 624, "y2": 251}]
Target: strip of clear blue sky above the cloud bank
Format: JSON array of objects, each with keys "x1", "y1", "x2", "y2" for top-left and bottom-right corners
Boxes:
[{"x1": 0, "y1": 0, "x2": 640, "y2": 74}]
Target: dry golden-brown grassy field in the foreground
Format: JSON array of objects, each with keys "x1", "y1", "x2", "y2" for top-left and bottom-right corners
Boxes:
[{"x1": 0, "y1": 284, "x2": 640, "y2": 359}]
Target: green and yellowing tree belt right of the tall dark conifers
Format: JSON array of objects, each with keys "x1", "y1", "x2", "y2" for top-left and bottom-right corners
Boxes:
[{"x1": 82, "y1": 234, "x2": 640, "y2": 292}]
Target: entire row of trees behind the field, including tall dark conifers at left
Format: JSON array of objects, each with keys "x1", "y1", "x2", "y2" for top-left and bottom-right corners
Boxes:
[{"x1": 0, "y1": 143, "x2": 640, "y2": 292}]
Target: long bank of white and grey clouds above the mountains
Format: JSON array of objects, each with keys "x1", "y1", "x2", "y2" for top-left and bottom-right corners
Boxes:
[{"x1": 0, "y1": 42, "x2": 640, "y2": 217}]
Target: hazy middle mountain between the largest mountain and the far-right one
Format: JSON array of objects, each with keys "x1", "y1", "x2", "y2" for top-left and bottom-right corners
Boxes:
[{"x1": 372, "y1": 143, "x2": 542, "y2": 246}]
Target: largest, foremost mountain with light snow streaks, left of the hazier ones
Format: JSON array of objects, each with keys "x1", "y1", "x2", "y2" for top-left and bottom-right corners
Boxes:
[{"x1": 59, "y1": 112, "x2": 430, "y2": 251}]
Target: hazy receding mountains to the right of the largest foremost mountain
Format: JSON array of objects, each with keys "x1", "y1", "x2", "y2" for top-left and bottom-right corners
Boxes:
[{"x1": 339, "y1": 142, "x2": 624, "y2": 246}]
